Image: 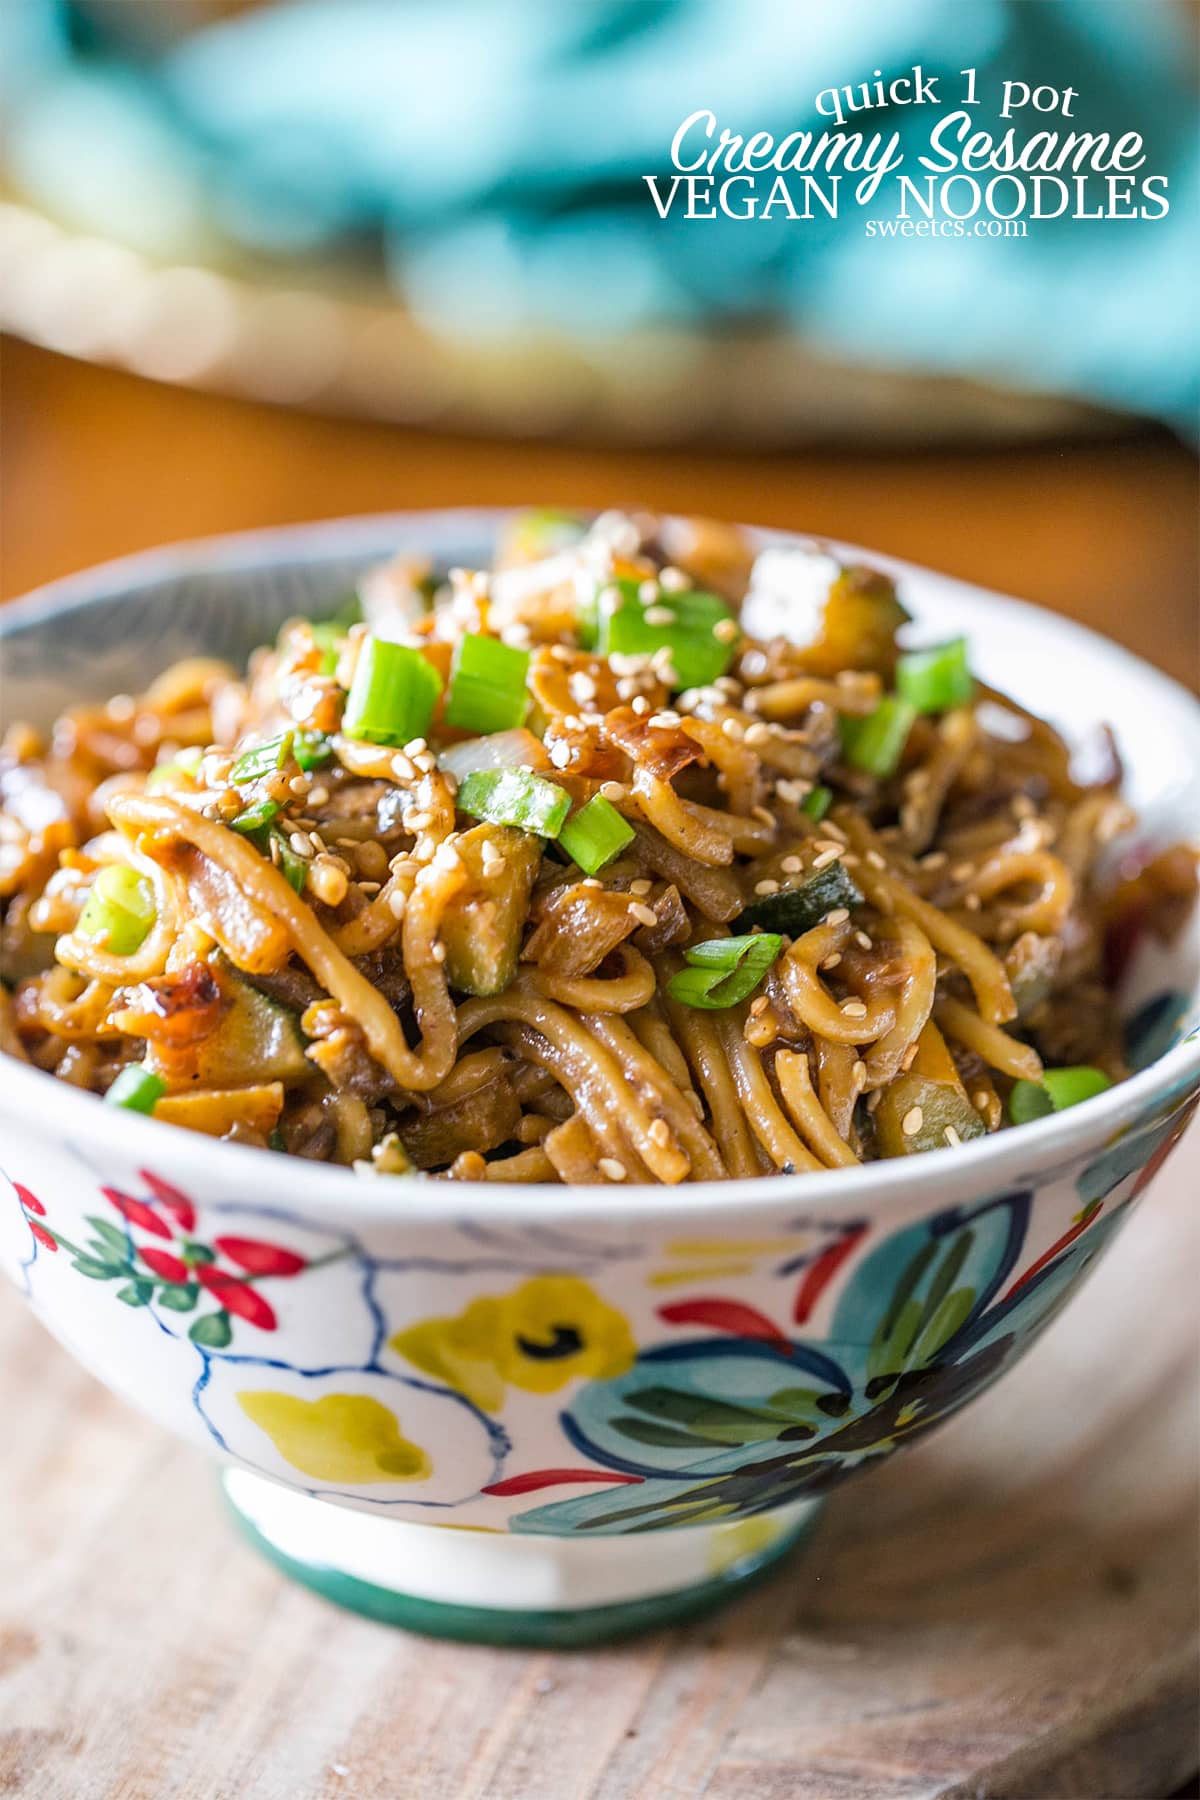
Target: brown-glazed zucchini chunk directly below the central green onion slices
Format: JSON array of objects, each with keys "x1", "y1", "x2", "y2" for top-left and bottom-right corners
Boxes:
[{"x1": 441, "y1": 824, "x2": 542, "y2": 994}]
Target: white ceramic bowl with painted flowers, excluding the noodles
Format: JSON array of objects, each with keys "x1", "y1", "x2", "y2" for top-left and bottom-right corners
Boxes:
[{"x1": 0, "y1": 513, "x2": 1200, "y2": 1643}]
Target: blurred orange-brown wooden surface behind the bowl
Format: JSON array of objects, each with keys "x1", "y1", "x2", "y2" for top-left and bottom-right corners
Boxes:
[{"x1": 0, "y1": 340, "x2": 1200, "y2": 686}]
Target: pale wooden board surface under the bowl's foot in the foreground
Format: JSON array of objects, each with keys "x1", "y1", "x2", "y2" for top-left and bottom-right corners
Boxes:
[{"x1": 0, "y1": 1132, "x2": 1200, "y2": 1800}]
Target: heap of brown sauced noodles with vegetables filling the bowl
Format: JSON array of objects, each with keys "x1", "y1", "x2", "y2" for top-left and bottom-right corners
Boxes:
[{"x1": 0, "y1": 515, "x2": 1196, "y2": 1184}]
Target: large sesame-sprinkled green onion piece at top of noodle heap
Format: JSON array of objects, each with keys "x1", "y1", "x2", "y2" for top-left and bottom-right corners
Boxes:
[{"x1": 579, "y1": 576, "x2": 741, "y2": 688}]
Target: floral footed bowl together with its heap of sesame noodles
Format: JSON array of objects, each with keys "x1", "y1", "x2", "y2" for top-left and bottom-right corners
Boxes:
[{"x1": 0, "y1": 509, "x2": 1200, "y2": 1643}]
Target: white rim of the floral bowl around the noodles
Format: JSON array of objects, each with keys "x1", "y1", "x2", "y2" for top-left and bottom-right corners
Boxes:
[{"x1": 0, "y1": 506, "x2": 1200, "y2": 1226}]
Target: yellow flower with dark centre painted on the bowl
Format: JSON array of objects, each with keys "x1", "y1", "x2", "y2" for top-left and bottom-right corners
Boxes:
[{"x1": 392, "y1": 1274, "x2": 637, "y2": 1411}]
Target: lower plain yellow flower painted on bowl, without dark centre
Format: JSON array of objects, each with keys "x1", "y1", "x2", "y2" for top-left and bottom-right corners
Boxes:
[{"x1": 237, "y1": 1388, "x2": 434, "y2": 1487}]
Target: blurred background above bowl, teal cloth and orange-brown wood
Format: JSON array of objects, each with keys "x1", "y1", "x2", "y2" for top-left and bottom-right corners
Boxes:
[{"x1": 0, "y1": 0, "x2": 1200, "y2": 684}]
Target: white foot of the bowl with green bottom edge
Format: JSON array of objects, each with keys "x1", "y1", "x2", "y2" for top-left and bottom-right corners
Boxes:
[{"x1": 221, "y1": 1469, "x2": 820, "y2": 1649}]
